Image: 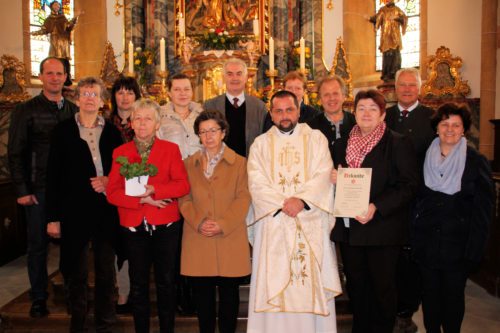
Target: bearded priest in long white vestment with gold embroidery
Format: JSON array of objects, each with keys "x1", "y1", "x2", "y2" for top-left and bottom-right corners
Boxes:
[{"x1": 247, "y1": 91, "x2": 342, "y2": 333}]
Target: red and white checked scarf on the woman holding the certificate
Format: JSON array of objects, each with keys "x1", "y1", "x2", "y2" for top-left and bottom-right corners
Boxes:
[{"x1": 346, "y1": 121, "x2": 386, "y2": 168}]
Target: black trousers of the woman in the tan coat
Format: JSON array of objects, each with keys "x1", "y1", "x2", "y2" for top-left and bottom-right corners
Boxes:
[{"x1": 189, "y1": 276, "x2": 241, "y2": 333}]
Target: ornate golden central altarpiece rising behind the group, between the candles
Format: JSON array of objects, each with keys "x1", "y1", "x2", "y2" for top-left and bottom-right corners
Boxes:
[{"x1": 174, "y1": 0, "x2": 271, "y2": 101}]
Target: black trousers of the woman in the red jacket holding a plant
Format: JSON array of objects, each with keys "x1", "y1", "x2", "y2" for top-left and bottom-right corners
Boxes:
[{"x1": 122, "y1": 222, "x2": 180, "y2": 333}]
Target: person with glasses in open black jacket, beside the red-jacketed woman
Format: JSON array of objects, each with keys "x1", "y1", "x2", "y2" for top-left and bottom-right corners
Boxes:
[{"x1": 47, "y1": 77, "x2": 122, "y2": 332}]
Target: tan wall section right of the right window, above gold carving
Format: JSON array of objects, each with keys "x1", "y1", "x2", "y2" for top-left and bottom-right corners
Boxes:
[{"x1": 427, "y1": 0, "x2": 482, "y2": 100}]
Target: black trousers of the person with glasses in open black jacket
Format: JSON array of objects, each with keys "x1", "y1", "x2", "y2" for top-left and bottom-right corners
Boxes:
[{"x1": 61, "y1": 234, "x2": 116, "y2": 332}]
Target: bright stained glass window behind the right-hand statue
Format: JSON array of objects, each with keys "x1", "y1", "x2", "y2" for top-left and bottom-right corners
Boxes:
[{"x1": 375, "y1": 0, "x2": 420, "y2": 71}]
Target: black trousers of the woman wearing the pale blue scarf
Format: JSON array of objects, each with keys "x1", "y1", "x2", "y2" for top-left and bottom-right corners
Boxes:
[{"x1": 420, "y1": 265, "x2": 467, "y2": 333}]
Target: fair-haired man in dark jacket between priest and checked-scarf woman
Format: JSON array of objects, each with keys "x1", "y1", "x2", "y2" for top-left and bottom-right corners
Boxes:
[{"x1": 307, "y1": 75, "x2": 356, "y2": 159}]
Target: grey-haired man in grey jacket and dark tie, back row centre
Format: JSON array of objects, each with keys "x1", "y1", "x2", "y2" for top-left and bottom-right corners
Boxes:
[{"x1": 204, "y1": 58, "x2": 266, "y2": 157}]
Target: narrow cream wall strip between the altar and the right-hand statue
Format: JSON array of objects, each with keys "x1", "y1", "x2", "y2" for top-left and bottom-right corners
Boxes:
[{"x1": 321, "y1": 0, "x2": 344, "y2": 70}]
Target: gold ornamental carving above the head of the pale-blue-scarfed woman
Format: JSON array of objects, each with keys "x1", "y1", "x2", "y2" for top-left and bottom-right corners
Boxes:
[{"x1": 422, "y1": 46, "x2": 470, "y2": 97}]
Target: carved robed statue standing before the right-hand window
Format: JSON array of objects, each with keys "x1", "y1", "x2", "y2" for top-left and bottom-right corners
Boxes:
[{"x1": 369, "y1": 0, "x2": 408, "y2": 82}]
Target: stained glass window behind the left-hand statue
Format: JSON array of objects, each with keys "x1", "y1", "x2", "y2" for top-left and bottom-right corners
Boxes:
[{"x1": 30, "y1": 0, "x2": 75, "y2": 77}]
